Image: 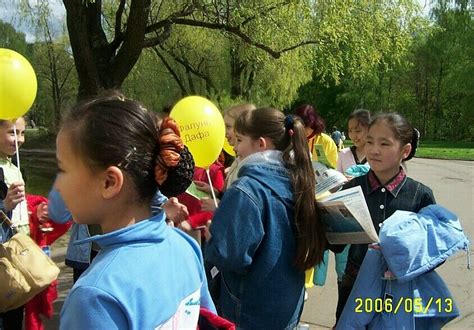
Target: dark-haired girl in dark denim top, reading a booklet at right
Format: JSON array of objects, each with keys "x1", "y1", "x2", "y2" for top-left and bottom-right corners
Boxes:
[{"x1": 336, "y1": 113, "x2": 435, "y2": 319}]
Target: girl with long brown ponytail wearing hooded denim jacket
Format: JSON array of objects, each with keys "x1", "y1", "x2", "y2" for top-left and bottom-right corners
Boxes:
[{"x1": 206, "y1": 108, "x2": 326, "y2": 329}]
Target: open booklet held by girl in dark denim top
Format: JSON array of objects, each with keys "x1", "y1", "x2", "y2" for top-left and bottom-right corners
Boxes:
[{"x1": 316, "y1": 186, "x2": 379, "y2": 244}]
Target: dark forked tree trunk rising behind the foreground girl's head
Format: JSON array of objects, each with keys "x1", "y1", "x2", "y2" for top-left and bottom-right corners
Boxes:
[{"x1": 63, "y1": 0, "x2": 151, "y2": 99}]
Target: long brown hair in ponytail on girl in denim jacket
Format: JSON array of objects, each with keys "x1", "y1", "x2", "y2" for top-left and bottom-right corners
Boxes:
[{"x1": 234, "y1": 108, "x2": 326, "y2": 270}]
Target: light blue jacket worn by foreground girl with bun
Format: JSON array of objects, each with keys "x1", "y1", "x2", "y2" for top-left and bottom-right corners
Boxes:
[{"x1": 60, "y1": 212, "x2": 215, "y2": 330}]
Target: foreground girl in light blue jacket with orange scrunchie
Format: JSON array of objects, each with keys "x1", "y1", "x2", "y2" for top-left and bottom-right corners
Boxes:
[{"x1": 55, "y1": 94, "x2": 214, "y2": 330}]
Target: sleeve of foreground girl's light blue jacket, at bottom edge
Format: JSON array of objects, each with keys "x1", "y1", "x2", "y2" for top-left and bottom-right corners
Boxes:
[{"x1": 59, "y1": 287, "x2": 129, "y2": 330}]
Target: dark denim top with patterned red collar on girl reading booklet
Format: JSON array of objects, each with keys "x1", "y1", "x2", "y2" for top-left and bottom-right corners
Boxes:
[{"x1": 344, "y1": 170, "x2": 435, "y2": 279}]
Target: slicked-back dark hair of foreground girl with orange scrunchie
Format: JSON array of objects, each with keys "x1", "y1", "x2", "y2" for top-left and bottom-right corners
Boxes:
[{"x1": 62, "y1": 91, "x2": 194, "y2": 203}]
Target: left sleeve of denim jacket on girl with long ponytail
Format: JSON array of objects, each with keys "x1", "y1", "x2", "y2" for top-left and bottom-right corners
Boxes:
[{"x1": 205, "y1": 186, "x2": 265, "y2": 273}]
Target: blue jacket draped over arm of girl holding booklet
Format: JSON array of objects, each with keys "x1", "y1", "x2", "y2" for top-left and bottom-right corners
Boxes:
[{"x1": 337, "y1": 205, "x2": 469, "y2": 329}]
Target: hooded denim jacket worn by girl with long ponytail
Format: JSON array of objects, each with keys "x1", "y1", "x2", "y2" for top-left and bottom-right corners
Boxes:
[{"x1": 205, "y1": 150, "x2": 304, "y2": 329}]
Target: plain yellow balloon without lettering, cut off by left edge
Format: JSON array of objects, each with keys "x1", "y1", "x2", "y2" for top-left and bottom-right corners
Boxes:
[{"x1": 0, "y1": 48, "x2": 37, "y2": 120}]
